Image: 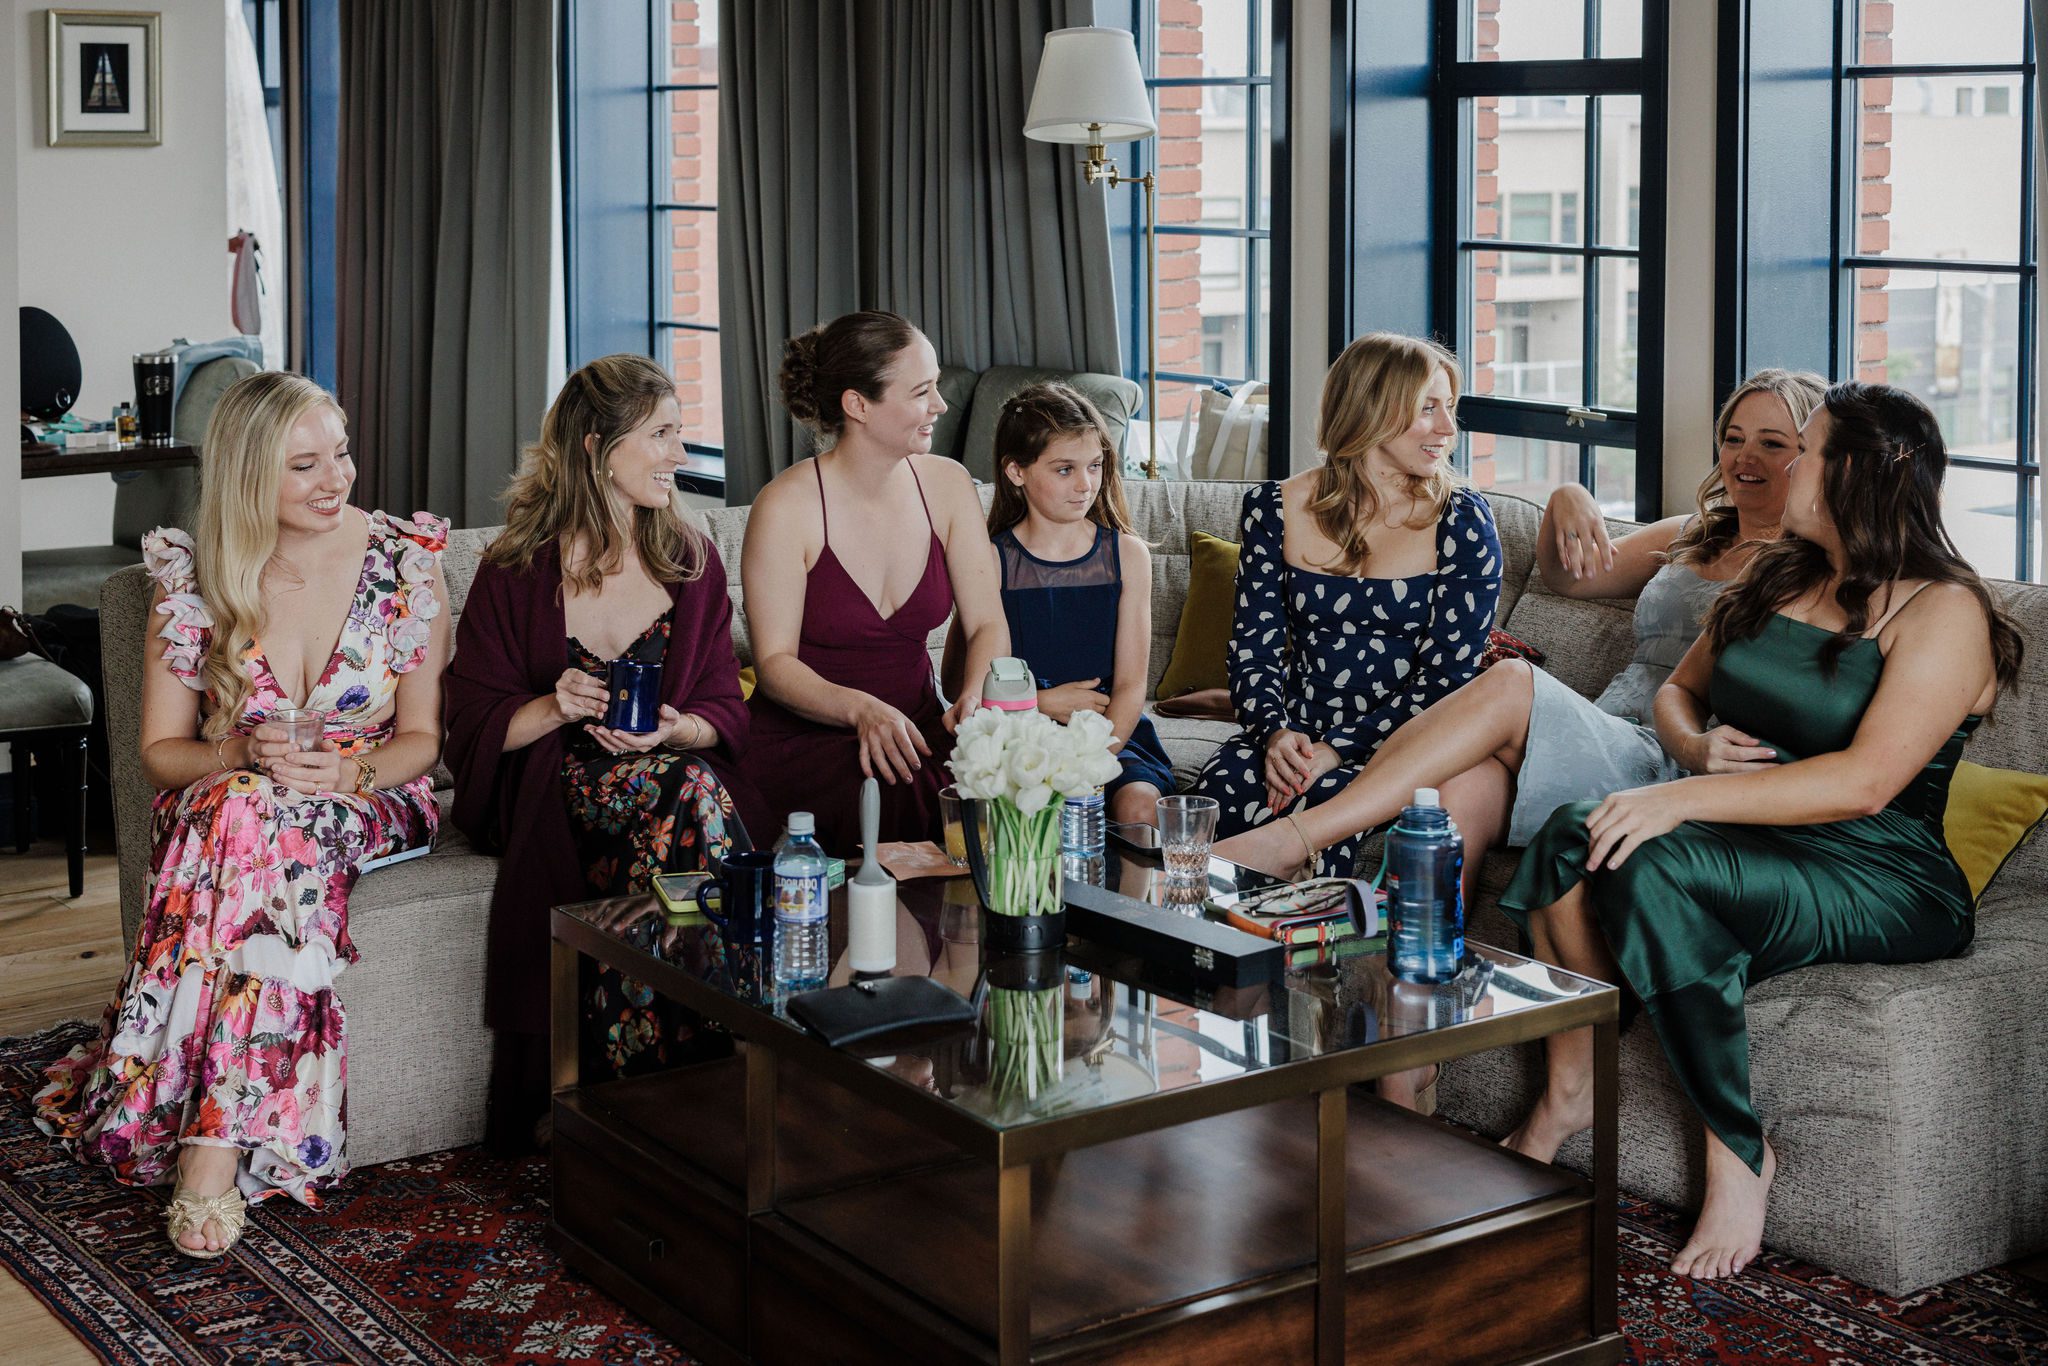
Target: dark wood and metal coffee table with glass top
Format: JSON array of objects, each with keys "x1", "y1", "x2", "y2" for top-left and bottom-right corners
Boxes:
[{"x1": 553, "y1": 854, "x2": 1622, "y2": 1362}]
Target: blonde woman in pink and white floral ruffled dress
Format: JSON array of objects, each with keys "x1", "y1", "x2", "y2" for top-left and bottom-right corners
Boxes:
[{"x1": 37, "y1": 371, "x2": 449, "y2": 1257}]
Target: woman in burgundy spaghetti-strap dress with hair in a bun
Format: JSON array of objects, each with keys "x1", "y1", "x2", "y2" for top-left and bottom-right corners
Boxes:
[{"x1": 739, "y1": 311, "x2": 1010, "y2": 854}]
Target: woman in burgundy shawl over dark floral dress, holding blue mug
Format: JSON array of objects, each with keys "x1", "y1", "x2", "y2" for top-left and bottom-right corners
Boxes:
[{"x1": 446, "y1": 356, "x2": 766, "y2": 1147}]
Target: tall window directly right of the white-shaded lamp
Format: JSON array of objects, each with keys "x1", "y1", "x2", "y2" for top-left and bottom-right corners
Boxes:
[{"x1": 1130, "y1": 0, "x2": 1290, "y2": 473}]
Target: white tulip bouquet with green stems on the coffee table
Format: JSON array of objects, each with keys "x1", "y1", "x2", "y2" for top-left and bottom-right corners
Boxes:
[{"x1": 950, "y1": 709, "x2": 1122, "y2": 915}]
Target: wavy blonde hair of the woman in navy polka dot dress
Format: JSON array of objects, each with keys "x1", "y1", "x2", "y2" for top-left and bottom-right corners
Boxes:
[{"x1": 1309, "y1": 332, "x2": 1464, "y2": 575}]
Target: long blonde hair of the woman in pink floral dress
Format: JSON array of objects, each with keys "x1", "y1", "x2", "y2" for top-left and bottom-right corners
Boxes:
[{"x1": 193, "y1": 371, "x2": 348, "y2": 739}]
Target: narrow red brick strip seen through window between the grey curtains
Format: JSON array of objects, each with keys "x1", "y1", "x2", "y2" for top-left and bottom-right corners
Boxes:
[{"x1": 664, "y1": 0, "x2": 725, "y2": 446}]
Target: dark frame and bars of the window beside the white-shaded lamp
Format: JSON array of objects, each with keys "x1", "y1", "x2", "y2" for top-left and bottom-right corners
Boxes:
[{"x1": 1122, "y1": 0, "x2": 1294, "y2": 479}]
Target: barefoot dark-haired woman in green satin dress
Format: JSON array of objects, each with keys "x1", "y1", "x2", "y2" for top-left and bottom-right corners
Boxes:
[{"x1": 1501, "y1": 383, "x2": 2021, "y2": 1278}]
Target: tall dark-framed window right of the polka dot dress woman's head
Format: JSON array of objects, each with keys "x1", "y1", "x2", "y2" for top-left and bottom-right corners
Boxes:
[{"x1": 1434, "y1": 0, "x2": 1665, "y2": 518}]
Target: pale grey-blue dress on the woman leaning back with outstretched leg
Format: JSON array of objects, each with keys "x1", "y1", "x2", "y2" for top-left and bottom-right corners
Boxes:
[{"x1": 1507, "y1": 565, "x2": 1726, "y2": 848}]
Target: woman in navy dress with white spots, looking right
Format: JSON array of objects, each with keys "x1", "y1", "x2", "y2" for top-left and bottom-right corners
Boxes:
[{"x1": 1190, "y1": 332, "x2": 1501, "y2": 877}]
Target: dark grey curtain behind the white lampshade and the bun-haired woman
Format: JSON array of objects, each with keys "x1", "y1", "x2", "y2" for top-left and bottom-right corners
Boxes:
[{"x1": 719, "y1": 0, "x2": 1122, "y2": 506}]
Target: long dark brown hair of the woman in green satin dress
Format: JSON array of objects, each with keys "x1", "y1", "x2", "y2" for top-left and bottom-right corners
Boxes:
[{"x1": 1704, "y1": 381, "x2": 2025, "y2": 690}]
